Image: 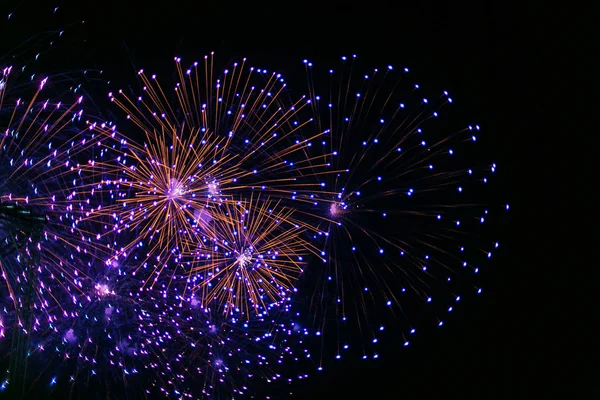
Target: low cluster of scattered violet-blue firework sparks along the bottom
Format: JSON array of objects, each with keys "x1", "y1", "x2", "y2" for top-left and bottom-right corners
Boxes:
[{"x1": 35, "y1": 239, "x2": 306, "y2": 398}]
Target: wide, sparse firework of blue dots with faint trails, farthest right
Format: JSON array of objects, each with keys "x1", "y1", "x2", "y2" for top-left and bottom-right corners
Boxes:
[{"x1": 272, "y1": 57, "x2": 504, "y2": 368}]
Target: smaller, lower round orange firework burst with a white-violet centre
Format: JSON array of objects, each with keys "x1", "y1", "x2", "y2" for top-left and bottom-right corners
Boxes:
[{"x1": 190, "y1": 198, "x2": 317, "y2": 315}]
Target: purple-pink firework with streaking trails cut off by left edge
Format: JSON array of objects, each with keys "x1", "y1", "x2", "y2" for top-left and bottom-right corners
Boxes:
[{"x1": 0, "y1": 25, "x2": 120, "y2": 394}]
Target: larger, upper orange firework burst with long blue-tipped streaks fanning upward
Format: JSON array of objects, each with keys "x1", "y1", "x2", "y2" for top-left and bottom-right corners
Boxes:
[{"x1": 91, "y1": 56, "x2": 332, "y2": 290}]
